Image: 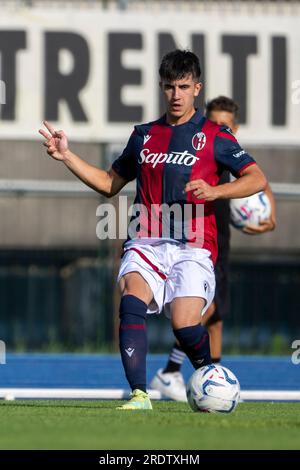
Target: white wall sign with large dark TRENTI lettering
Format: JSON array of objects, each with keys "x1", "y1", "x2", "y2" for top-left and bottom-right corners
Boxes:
[{"x1": 0, "y1": 8, "x2": 300, "y2": 142}]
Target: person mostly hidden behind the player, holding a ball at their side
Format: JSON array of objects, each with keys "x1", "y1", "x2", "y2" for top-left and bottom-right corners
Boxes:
[{"x1": 150, "y1": 96, "x2": 276, "y2": 401}]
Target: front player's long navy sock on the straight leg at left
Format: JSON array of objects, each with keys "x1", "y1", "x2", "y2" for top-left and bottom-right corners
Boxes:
[{"x1": 119, "y1": 295, "x2": 147, "y2": 392}]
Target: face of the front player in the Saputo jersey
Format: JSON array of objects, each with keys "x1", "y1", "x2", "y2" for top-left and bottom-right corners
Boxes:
[{"x1": 160, "y1": 74, "x2": 202, "y2": 125}]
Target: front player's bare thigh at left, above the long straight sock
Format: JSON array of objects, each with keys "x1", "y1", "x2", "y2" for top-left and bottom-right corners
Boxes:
[{"x1": 119, "y1": 271, "x2": 153, "y2": 305}]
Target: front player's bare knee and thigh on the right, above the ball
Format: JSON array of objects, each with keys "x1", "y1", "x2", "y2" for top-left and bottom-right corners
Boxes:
[{"x1": 170, "y1": 297, "x2": 206, "y2": 330}]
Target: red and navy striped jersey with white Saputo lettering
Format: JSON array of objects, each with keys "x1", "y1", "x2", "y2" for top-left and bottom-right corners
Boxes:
[{"x1": 112, "y1": 111, "x2": 255, "y2": 262}]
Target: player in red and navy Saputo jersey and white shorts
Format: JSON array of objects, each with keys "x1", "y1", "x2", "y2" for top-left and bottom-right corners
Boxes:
[{"x1": 40, "y1": 50, "x2": 266, "y2": 410}]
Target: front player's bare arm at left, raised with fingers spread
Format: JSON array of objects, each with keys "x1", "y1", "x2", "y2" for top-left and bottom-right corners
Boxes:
[{"x1": 39, "y1": 121, "x2": 128, "y2": 197}]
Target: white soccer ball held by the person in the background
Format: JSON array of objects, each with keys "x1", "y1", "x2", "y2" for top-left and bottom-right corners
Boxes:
[{"x1": 230, "y1": 191, "x2": 271, "y2": 230}]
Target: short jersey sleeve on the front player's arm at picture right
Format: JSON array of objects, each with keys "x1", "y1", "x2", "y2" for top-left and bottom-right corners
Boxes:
[{"x1": 214, "y1": 127, "x2": 256, "y2": 177}]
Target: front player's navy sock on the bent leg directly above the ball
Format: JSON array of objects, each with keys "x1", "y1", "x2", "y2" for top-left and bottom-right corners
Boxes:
[{"x1": 174, "y1": 325, "x2": 211, "y2": 369}]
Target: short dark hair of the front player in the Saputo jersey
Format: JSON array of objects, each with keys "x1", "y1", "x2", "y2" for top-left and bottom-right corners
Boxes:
[{"x1": 159, "y1": 49, "x2": 201, "y2": 82}]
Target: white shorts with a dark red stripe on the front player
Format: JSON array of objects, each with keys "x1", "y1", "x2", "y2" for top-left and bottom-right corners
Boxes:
[{"x1": 118, "y1": 241, "x2": 215, "y2": 318}]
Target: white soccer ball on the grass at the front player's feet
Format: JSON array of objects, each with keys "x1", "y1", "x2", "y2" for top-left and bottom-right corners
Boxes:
[{"x1": 186, "y1": 364, "x2": 240, "y2": 413}]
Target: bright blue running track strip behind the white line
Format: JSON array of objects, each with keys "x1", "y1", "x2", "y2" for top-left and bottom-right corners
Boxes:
[{"x1": 0, "y1": 354, "x2": 300, "y2": 390}]
